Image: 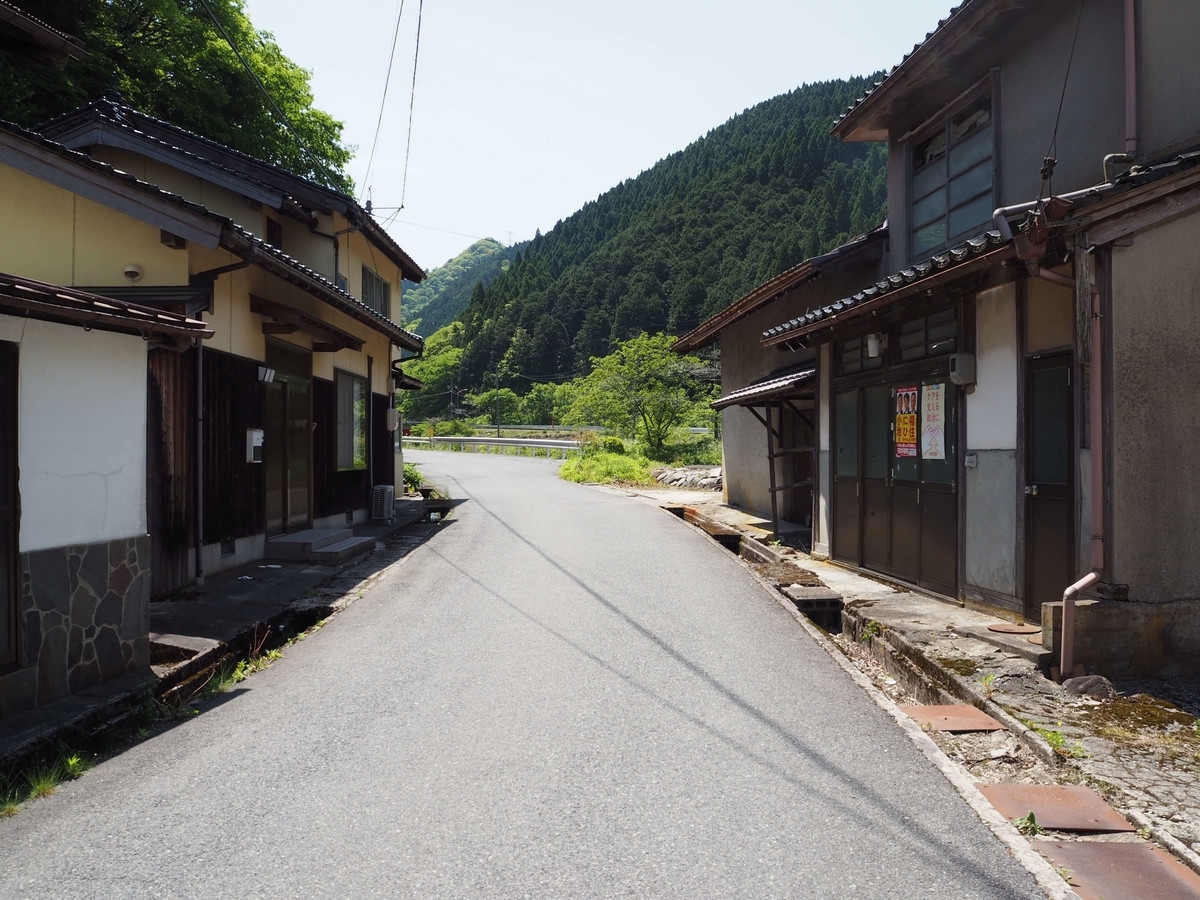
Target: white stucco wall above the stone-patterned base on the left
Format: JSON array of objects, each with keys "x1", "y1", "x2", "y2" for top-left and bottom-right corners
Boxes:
[{"x1": 0, "y1": 316, "x2": 146, "y2": 553}]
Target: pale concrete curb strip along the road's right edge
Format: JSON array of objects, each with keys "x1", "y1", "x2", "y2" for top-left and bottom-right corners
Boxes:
[{"x1": 652, "y1": 504, "x2": 1080, "y2": 900}]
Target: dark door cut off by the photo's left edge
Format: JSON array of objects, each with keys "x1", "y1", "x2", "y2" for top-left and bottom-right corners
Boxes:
[{"x1": 0, "y1": 343, "x2": 18, "y2": 671}]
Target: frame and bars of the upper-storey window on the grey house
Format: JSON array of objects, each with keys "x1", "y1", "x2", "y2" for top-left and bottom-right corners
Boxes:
[{"x1": 902, "y1": 84, "x2": 1000, "y2": 262}]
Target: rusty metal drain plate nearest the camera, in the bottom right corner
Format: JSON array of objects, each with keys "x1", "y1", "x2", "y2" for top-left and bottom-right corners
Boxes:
[{"x1": 1033, "y1": 841, "x2": 1200, "y2": 900}]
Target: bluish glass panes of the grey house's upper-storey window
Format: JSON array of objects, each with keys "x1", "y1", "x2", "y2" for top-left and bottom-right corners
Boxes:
[{"x1": 908, "y1": 95, "x2": 996, "y2": 259}]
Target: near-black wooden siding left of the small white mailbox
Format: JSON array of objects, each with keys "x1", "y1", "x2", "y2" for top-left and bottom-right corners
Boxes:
[{"x1": 204, "y1": 349, "x2": 266, "y2": 544}]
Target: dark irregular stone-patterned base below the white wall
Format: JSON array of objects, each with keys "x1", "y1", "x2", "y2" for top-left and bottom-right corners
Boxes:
[{"x1": 0, "y1": 536, "x2": 150, "y2": 718}]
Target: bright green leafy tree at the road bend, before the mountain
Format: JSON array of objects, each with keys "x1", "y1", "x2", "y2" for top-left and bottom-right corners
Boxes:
[{"x1": 570, "y1": 334, "x2": 703, "y2": 458}]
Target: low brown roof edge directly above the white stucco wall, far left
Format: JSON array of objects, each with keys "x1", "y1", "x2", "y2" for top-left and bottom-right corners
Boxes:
[{"x1": 0, "y1": 274, "x2": 212, "y2": 340}]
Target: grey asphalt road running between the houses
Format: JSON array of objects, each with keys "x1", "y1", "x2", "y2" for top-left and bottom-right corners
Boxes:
[{"x1": 0, "y1": 452, "x2": 1042, "y2": 900}]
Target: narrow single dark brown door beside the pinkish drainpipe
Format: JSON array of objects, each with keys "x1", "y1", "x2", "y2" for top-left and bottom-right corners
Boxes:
[{"x1": 1025, "y1": 355, "x2": 1075, "y2": 622}]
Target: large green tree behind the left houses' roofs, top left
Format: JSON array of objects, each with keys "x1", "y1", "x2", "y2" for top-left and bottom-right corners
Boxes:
[{"x1": 0, "y1": 0, "x2": 353, "y2": 191}]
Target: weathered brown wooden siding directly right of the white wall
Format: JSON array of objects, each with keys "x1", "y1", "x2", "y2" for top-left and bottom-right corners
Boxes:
[{"x1": 146, "y1": 349, "x2": 196, "y2": 596}]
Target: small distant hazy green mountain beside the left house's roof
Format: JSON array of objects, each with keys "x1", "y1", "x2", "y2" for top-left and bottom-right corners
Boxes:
[{"x1": 403, "y1": 238, "x2": 529, "y2": 335}]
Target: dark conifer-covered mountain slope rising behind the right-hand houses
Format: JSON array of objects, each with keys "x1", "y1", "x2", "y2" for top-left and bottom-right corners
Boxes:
[{"x1": 456, "y1": 78, "x2": 887, "y2": 392}]
